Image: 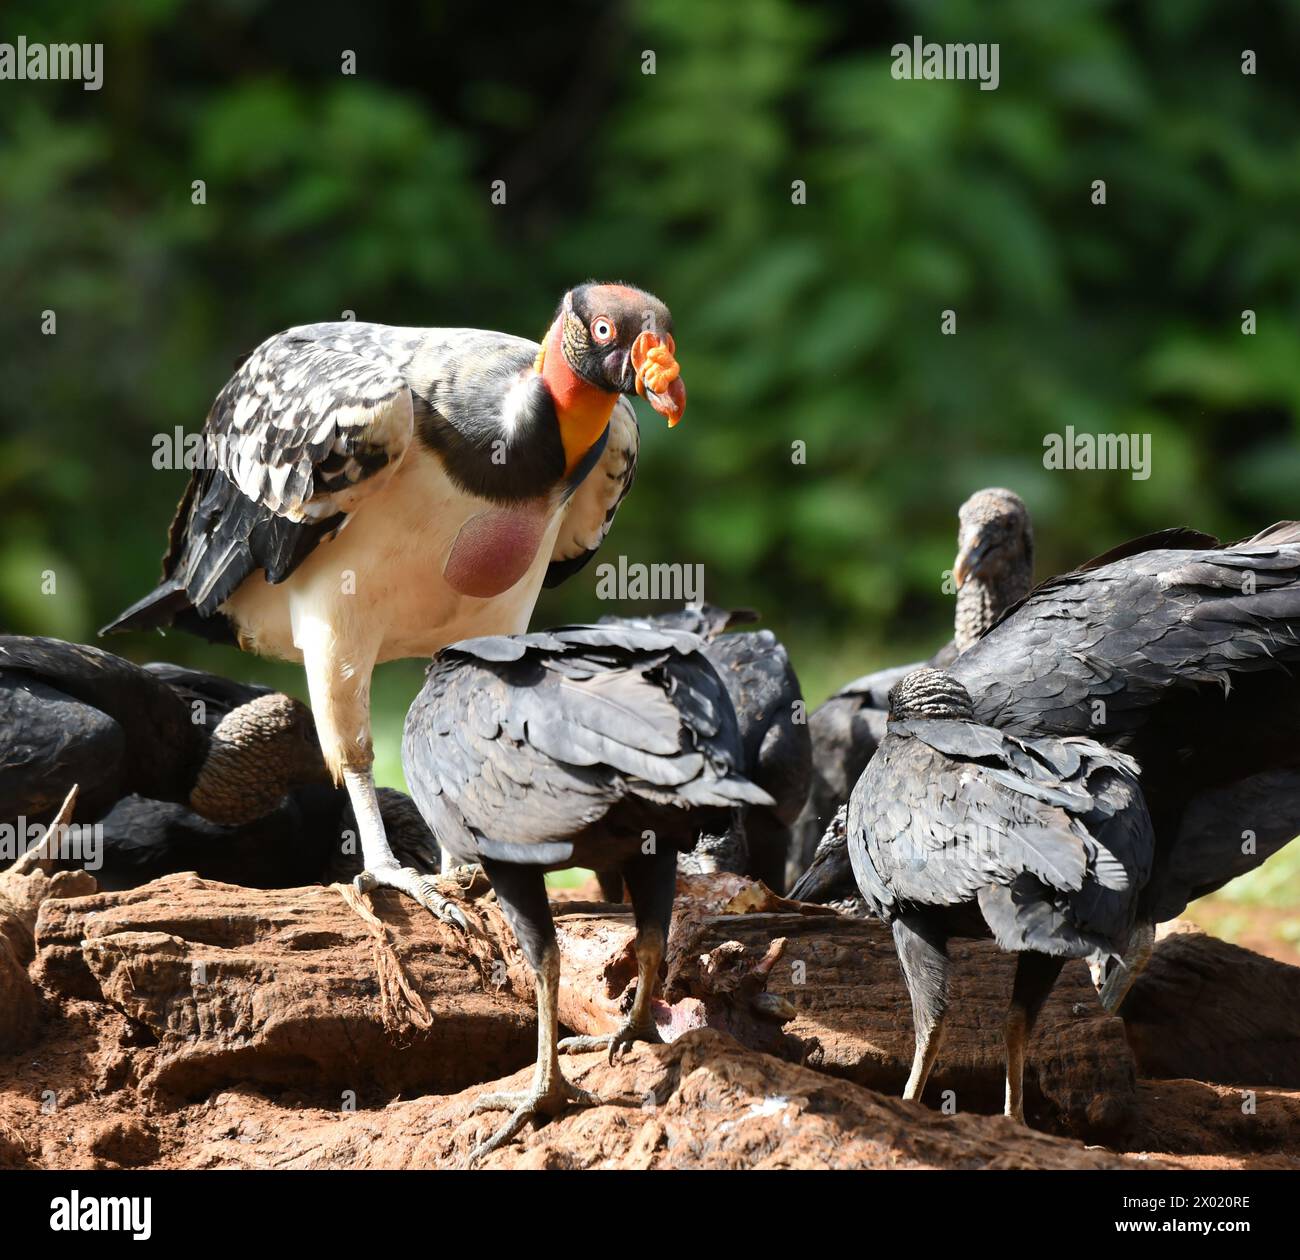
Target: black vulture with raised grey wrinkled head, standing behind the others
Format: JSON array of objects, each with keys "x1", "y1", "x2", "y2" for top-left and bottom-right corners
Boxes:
[{"x1": 789, "y1": 489, "x2": 1034, "y2": 902}]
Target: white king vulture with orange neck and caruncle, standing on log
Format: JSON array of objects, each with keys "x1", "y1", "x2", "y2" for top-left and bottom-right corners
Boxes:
[{"x1": 107, "y1": 283, "x2": 686, "y2": 919}]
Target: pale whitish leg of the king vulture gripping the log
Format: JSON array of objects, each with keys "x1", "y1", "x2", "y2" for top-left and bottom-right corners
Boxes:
[{"x1": 294, "y1": 615, "x2": 469, "y2": 931}]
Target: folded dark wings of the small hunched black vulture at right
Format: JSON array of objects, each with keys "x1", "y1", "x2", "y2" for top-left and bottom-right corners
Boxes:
[{"x1": 846, "y1": 720, "x2": 1151, "y2": 956}]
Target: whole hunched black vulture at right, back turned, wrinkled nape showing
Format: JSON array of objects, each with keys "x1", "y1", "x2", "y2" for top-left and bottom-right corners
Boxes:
[{"x1": 845, "y1": 668, "x2": 1154, "y2": 1121}]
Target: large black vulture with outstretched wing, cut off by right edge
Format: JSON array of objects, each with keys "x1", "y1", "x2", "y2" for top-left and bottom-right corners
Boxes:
[{"x1": 952, "y1": 521, "x2": 1300, "y2": 1010}]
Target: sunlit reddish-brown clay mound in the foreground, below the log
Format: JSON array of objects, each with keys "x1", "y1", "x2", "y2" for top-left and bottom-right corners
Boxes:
[{"x1": 0, "y1": 1001, "x2": 1159, "y2": 1169}]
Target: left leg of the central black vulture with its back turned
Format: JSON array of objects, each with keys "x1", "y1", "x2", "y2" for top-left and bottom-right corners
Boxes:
[{"x1": 469, "y1": 861, "x2": 601, "y2": 1164}]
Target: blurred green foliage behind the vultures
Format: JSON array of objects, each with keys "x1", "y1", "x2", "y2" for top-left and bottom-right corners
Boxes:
[{"x1": 0, "y1": 0, "x2": 1300, "y2": 925}]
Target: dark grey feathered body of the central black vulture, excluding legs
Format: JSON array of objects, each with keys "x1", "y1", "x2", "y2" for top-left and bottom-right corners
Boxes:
[{"x1": 403, "y1": 625, "x2": 771, "y2": 865}]
